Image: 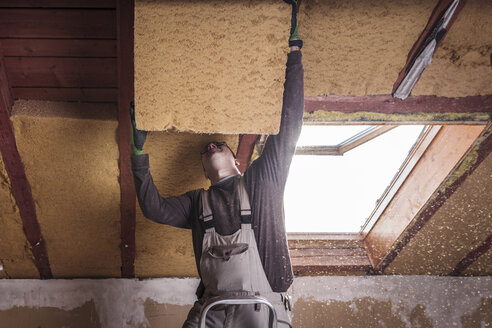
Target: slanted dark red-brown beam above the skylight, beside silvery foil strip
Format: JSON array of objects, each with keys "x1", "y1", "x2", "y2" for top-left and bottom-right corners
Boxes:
[{"x1": 391, "y1": 0, "x2": 467, "y2": 95}]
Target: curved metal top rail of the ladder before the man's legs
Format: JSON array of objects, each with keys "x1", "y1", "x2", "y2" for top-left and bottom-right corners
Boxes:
[{"x1": 198, "y1": 296, "x2": 277, "y2": 328}]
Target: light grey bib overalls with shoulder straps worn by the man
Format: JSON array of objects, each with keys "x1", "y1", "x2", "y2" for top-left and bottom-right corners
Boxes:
[{"x1": 183, "y1": 177, "x2": 291, "y2": 328}]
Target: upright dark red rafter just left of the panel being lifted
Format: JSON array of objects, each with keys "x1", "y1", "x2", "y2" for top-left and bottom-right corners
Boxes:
[{"x1": 117, "y1": 0, "x2": 136, "y2": 278}]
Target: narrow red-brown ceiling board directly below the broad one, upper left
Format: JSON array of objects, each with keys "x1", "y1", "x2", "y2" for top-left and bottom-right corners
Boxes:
[{"x1": 2, "y1": 39, "x2": 116, "y2": 58}]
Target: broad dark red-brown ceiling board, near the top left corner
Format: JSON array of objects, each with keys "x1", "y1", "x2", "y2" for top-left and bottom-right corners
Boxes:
[{"x1": 0, "y1": 8, "x2": 116, "y2": 39}]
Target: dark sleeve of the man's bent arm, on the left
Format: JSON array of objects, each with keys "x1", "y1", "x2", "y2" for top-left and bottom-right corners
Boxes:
[{"x1": 132, "y1": 154, "x2": 192, "y2": 229}]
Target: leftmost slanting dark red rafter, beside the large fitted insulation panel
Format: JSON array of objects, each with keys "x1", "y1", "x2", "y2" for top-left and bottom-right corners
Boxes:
[{"x1": 0, "y1": 50, "x2": 52, "y2": 279}]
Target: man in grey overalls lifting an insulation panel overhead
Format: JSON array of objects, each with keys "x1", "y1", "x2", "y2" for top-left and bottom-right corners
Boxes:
[{"x1": 132, "y1": 0, "x2": 304, "y2": 328}]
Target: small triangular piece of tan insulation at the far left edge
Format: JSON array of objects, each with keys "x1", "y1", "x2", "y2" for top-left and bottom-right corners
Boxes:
[{"x1": 0, "y1": 156, "x2": 39, "y2": 278}]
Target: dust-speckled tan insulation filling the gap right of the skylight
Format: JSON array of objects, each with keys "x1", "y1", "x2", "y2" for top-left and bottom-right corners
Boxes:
[{"x1": 385, "y1": 154, "x2": 492, "y2": 274}]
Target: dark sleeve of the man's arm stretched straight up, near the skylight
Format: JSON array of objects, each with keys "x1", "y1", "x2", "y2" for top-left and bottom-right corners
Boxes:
[{"x1": 250, "y1": 51, "x2": 304, "y2": 189}]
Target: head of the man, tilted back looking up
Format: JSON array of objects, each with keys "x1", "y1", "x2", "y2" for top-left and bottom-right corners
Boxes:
[{"x1": 200, "y1": 141, "x2": 239, "y2": 184}]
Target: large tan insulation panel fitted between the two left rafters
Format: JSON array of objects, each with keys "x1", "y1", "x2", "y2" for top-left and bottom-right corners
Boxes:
[{"x1": 12, "y1": 101, "x2": 121, "y2": 278}]
